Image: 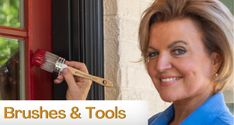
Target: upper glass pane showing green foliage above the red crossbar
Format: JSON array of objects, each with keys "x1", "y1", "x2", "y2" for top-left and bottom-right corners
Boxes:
[{"x1": 0, "y1": 0, "x2": 23, "y2": 28}]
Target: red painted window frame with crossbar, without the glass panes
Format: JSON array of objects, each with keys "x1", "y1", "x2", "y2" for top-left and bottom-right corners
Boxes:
[{"x1": 0, "y1": 0, "x2": 52, "y2": 100}]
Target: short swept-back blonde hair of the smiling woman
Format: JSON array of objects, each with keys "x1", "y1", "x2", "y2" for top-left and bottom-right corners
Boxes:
[{"x1": 139, "y1": 0, "x2": 234, "y2": 92}]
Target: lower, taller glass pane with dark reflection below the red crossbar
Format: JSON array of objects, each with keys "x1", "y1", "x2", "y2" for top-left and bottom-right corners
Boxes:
[{"x1": 0, "y1": 37, "x2": 25, "y2": 100}]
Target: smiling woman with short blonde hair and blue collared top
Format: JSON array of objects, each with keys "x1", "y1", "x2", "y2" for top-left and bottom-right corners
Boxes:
[{"x1": 139, "y1": 0, "x2": 234, "y2": 125}]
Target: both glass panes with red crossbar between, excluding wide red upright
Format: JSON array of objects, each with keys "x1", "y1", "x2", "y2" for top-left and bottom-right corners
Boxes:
[{"x1": 0, "y1": 0, "x2": 25, "y2": 99}]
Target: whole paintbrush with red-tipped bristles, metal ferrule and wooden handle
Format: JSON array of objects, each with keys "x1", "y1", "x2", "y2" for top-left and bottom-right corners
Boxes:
[{"x1": 32, "y1": 49, "x2": 113, "y2": 87}]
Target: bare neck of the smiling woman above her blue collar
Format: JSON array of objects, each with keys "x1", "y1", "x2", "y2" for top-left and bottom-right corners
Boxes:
[{"x1": 170, "y1": 87, "x2": 213, "y2": 125}]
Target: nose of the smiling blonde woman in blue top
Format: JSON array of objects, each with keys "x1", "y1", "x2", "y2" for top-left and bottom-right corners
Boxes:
[{"x1": 156, "y1": 55, "x2": 172, "y2": 72}]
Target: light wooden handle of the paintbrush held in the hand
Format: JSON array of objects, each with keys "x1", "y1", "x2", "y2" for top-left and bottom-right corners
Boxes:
[{"x1": 67, "y1": 66, "x2": 113, "y2": 87}]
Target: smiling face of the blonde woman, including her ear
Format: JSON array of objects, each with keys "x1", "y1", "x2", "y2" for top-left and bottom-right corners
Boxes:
[{"x1": 146, "y1": 19, "x2": 217, "y2": 102}]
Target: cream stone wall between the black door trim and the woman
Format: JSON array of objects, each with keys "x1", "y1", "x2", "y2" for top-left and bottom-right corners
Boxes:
[{"x1": 104, "y1": 0, "x2": 168, "y2": 115}]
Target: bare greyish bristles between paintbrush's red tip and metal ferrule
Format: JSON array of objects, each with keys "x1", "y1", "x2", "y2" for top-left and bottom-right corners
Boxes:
[{"x1": 41, "y1": 52, "x2": 59, "y2": 72}]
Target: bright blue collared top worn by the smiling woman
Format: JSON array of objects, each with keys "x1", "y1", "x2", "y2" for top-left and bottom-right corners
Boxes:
[{"x1": 149, "y1": 93, "x2": 234, "y2": 125}]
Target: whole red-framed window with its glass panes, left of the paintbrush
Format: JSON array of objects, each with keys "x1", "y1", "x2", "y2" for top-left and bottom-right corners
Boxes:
[{"x1": 0, "y1": 0, "x2": 52, "y2": 99}]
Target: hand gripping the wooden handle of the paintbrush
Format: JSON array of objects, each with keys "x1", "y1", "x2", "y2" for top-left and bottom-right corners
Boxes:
[{"x1": 54, "y1": 61, "x2": 92, "y2": 100}]
